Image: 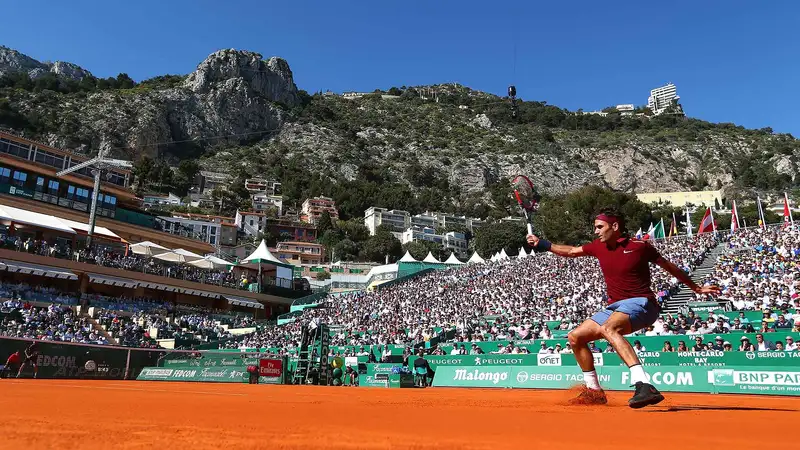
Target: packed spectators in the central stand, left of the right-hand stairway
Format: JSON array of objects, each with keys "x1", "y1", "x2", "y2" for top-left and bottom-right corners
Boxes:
[{"x1": 227, "y1": 234, "x2": 718, "y2": 349}]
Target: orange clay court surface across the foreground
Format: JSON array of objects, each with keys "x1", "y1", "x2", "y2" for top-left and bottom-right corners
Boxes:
[{"x1": 0, "y1": 379, "x2": 800, "y2": 450}]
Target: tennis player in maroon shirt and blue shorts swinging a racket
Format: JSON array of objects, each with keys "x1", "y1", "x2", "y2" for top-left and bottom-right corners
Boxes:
[{"x1": 528, "y1": 208, "x2": 720, "y2": 408}]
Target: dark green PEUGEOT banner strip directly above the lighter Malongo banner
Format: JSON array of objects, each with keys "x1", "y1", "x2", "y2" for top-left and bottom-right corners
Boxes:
[{"x1": 422, "y1": 350, "x2": 800, "y2": 369}]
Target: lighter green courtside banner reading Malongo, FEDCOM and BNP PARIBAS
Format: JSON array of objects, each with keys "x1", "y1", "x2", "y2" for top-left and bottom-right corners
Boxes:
[{"x1": 433, "y1": 366, "x2": 800, "y2": 395}]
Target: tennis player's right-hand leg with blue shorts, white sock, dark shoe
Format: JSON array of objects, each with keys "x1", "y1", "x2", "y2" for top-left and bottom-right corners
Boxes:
[{"x1": 600, "y1": 298, "x2": 664, "y2": 408}]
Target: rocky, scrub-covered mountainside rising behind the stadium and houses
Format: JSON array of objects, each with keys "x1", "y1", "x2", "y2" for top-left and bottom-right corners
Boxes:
[{"x1": 0, "y1": 45, "x2": 800, "y2": 217}]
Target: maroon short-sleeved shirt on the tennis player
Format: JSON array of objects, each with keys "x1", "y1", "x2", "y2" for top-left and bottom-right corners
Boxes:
[{"x1": 583, "y1": 237, "x2": 661, "y2": 305}]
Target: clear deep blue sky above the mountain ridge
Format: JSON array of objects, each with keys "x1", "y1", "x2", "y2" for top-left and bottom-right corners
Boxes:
[{"x1": 0, "y1": 0, "x2": 800, "y2": 136}]
